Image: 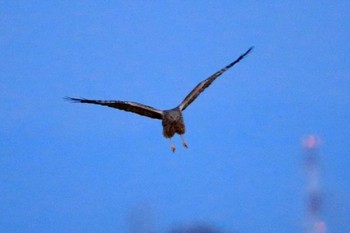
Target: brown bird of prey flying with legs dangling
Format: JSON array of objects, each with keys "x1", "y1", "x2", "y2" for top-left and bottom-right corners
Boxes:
[{"x1": 66, "y1": 47, "x2": 253, "y2": 152}]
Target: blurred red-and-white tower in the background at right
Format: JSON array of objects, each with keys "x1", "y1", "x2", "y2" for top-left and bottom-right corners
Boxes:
[{"x1": 303, "y1": 135, "x2": 327, "y2": 233}]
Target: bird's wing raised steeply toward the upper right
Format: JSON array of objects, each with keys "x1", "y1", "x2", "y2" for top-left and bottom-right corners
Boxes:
[{"x1": 178, "y1": 47, "x2": 253, "y2": 111}]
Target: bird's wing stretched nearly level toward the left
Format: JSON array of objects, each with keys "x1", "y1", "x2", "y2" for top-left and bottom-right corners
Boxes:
[{"x1": 65, "y1": 97, "x2": 163, "y2": 119}]
